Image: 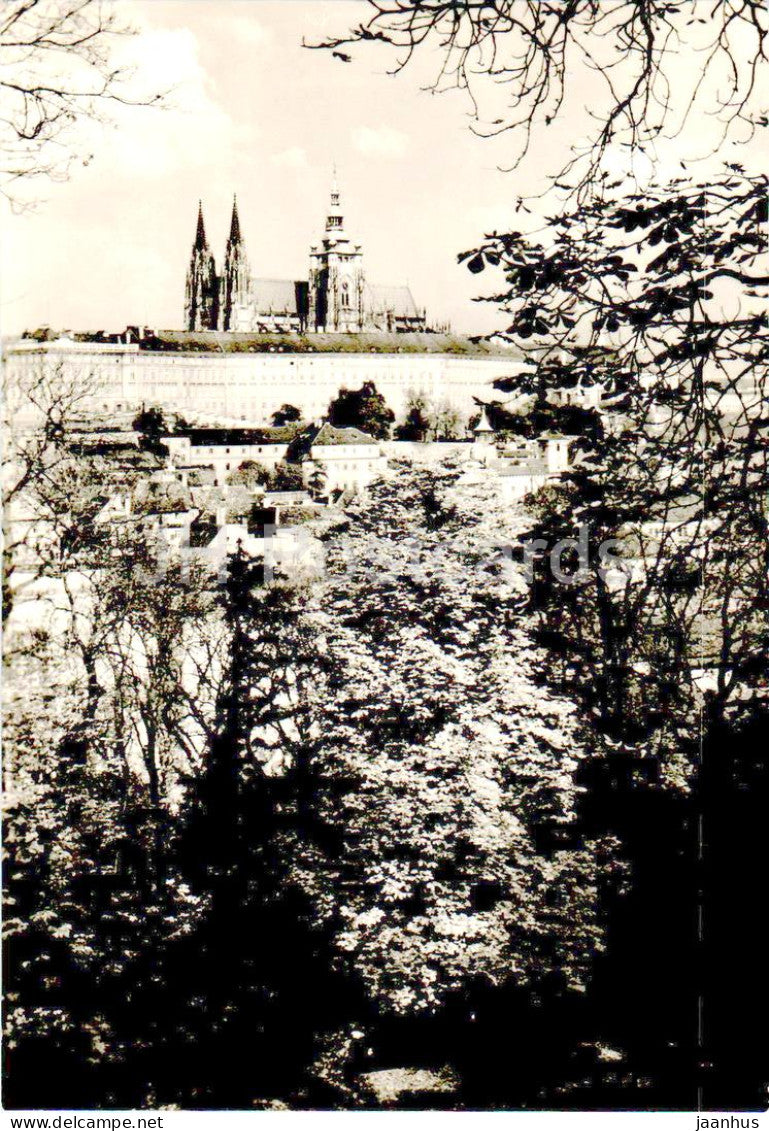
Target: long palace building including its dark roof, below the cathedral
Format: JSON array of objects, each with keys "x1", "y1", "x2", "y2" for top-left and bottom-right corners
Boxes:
[{"x1": 5, "y1": 330, "x2": 526, "y2": 426}]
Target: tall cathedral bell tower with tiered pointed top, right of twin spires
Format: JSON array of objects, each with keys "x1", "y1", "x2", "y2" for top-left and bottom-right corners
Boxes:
[{"x1": 309, "y1": 174, "x2": 364, "y2": 334}]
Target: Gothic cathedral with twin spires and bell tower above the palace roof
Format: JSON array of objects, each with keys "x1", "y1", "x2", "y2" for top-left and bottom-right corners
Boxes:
[{"x1": 184, "y1": 180, "x2": 426, "y2": 334}]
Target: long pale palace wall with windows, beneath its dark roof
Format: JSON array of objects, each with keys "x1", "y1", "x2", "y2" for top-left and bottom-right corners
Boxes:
[{"x1": 5, "y1": 338, "x2": 522, "y2": 425}]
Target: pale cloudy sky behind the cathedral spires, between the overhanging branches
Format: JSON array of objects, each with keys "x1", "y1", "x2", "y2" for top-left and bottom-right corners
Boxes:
[{"x1": 1, "y1": 0, "x2": 764, "y2": 334}]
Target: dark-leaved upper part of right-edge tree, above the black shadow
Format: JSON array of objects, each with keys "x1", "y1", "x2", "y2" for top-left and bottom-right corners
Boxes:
[{"x1": 468, "y1": 167, "x2": 769, "y2": 749}]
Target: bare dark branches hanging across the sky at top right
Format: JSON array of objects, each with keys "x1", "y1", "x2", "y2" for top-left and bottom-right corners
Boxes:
[{"x1": 304, "y1": 0, "x2": 769, "y2": 189}]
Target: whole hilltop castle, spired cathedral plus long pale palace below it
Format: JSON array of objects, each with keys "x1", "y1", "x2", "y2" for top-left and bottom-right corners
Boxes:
[{"x1": 5, "y1": 184, "x2": 524, "y2": 426}]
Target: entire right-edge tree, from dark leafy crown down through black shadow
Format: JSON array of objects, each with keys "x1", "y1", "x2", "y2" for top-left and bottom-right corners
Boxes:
[{"x1": 466, "y1": 166, "x2": 769, "y2": 1107}]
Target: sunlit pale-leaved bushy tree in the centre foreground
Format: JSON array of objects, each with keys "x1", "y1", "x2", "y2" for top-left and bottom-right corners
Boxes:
[{"x1": 284, "y1": 467, "x2": 604, "y2": 1015}]
